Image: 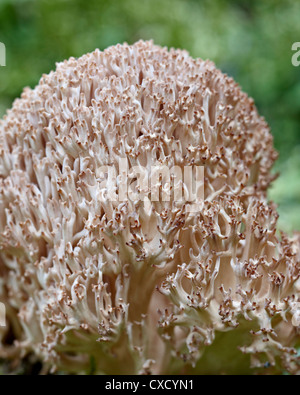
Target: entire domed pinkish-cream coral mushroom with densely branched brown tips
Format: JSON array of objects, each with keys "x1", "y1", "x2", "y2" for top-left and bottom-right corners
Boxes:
[{"x1": 0, "y1": 41, "x2": 300, "y2": 374}]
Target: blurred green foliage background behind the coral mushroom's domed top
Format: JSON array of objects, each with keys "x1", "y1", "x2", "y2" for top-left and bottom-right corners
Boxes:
[{"x1": 0, "y1": 0, "x2": 300, "y2": 231}]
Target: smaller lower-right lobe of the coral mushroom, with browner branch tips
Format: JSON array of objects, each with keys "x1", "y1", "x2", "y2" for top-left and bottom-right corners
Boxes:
[{"x1": 160, "y1": 199, "x2": 300, "y2": 373}]
